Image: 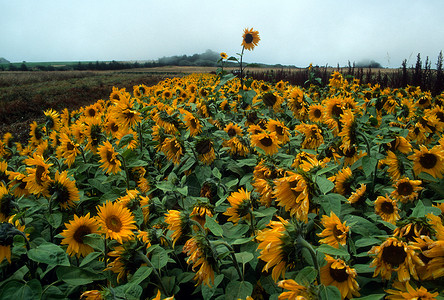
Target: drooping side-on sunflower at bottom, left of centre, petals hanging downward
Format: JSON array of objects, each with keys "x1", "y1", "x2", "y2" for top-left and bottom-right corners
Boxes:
[{"x1": 182, "y1": 234, "x2": 217, "y2": 288}]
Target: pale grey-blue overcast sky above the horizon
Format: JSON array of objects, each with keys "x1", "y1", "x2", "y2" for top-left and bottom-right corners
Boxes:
[{"x1": 0, "y1": 0, "x2": 444, "y2": 68}]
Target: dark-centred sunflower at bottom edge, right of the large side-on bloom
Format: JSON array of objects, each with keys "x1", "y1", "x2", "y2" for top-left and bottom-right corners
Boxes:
[{"x1": 321, "y1": 254, "x2": 360, "y2": 299}]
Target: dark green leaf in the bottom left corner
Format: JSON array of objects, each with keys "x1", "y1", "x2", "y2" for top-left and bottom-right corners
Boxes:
[{"x1": 0, "y1": 279, "x2": 42, "y2": 300}]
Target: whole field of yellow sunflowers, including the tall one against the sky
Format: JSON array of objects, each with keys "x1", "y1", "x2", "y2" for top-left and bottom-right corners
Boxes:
[{"x1": 0, "y1": 29, "x2": 444, "y2": 300}]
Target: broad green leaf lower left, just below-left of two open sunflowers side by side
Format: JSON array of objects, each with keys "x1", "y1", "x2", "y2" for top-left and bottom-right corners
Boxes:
[{"x1": 28, "y1": 243, "x2": 70, "y2": 266}]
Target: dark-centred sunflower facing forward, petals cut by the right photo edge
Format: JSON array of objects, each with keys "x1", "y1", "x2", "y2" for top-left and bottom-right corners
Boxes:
[{"x1": 408, "y1": 145, "x2": 444, "y2": 178}]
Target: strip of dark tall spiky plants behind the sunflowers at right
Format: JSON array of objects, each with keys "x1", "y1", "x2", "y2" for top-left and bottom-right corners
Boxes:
[{"x1": 247, "y1": 51, "x2": 444, "y2": 95}]
